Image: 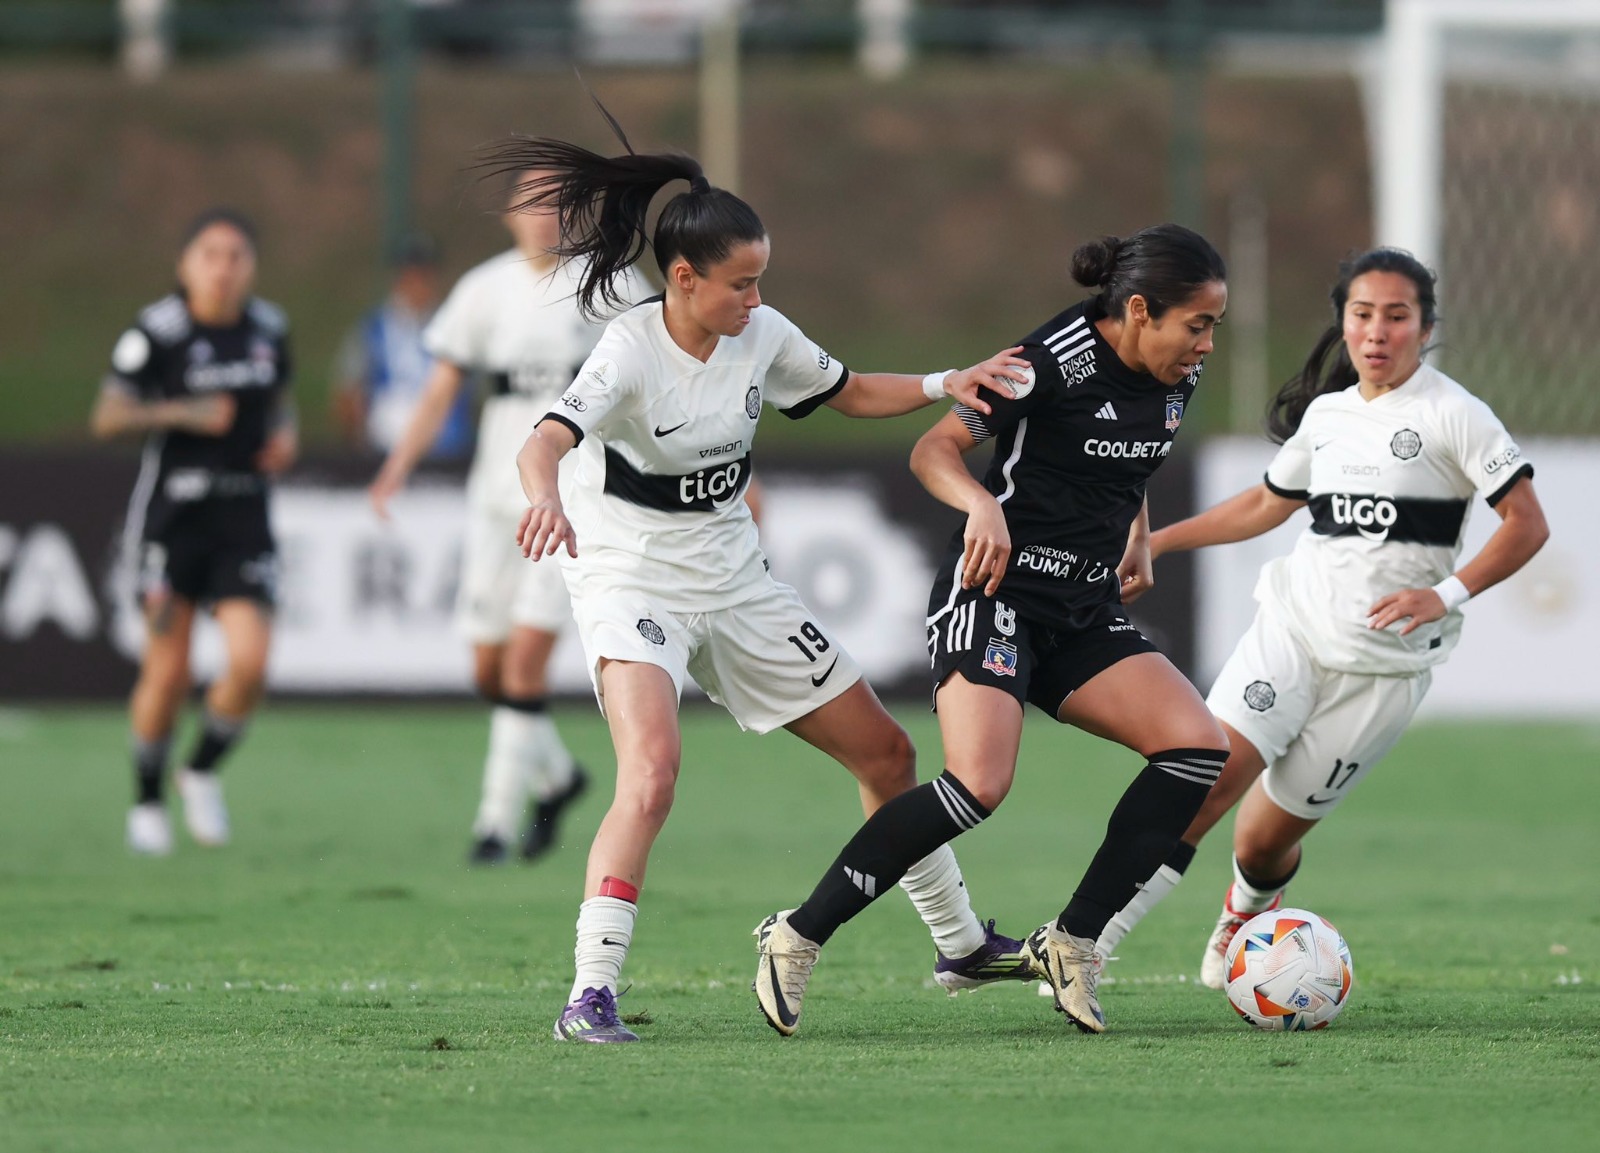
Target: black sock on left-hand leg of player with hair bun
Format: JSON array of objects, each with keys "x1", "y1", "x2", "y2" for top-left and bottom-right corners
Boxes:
[{"x1": 789, "y1": 771, "x2": 989, "y2": 945}]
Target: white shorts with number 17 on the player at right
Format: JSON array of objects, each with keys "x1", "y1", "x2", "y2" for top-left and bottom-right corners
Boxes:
[{"x1": 1206, "y1": 609, "x2": 1434, "y2": 820}]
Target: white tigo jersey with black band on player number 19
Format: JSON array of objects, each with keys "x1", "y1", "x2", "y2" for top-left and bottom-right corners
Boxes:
[{"x1": 544, "y1": 297, "x2": 850, "y2": 612}]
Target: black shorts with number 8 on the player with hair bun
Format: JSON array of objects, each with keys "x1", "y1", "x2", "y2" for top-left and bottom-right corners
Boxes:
[{"x1": 928, "y1": 588, "x2": 1160, "y2": 716}]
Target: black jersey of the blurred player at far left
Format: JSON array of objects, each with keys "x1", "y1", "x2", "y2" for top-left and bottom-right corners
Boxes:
[{"x1": 110, "y1": 293, "x2": 290, "y2": 501}]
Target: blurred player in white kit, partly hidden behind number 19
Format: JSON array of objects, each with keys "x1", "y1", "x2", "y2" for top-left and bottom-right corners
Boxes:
[{"x1": 370, "y1": 179, "x2": 643, "y2": 865}]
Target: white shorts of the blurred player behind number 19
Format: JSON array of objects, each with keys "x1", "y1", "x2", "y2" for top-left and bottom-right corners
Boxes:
[{"x1": 456, "y1": 505, "x2": 573, "y2": 644}]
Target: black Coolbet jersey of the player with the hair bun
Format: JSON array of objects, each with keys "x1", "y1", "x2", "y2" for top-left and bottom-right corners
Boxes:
[{"x1": 930, "y1": 296, "x2": 1200, "y2": 628}]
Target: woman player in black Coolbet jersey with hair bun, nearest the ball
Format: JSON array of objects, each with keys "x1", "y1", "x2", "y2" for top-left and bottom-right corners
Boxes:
[{"x1": 755, "y1": 224, "x2": 1227, "y2": 1035}]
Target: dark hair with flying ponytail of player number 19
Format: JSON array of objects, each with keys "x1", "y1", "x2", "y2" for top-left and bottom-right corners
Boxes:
[{"x1": 478, "y1": 101, "x2": 766, "y2": 317}]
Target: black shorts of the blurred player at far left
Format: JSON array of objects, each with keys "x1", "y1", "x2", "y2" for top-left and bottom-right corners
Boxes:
[{"x1": 139, "y1": 499, "x2": 278, "y2": 608}]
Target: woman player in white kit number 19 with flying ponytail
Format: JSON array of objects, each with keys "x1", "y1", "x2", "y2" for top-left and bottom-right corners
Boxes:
[{"x1": 494, "y1": 122, "x2": 1029, "y2": 1043}]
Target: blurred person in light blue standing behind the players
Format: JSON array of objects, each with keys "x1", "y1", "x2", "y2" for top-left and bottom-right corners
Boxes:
[{"x1": 331, "y1": 233, "x2": 472, "y2": 461}]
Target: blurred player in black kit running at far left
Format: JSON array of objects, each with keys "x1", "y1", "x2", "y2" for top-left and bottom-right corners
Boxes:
[{"x1": 90, "y1": 209, "x2": 298, "y2": 856}]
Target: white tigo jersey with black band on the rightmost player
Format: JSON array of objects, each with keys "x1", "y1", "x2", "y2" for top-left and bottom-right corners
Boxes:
[{"x1": 1256, "y1": 365, "x2": 1533, "y2": 675}]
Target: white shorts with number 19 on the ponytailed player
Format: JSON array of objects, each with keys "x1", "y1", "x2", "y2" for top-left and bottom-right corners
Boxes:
[{"x1": 573, "y1": 577, "x2": 861, "y2": 732}]
